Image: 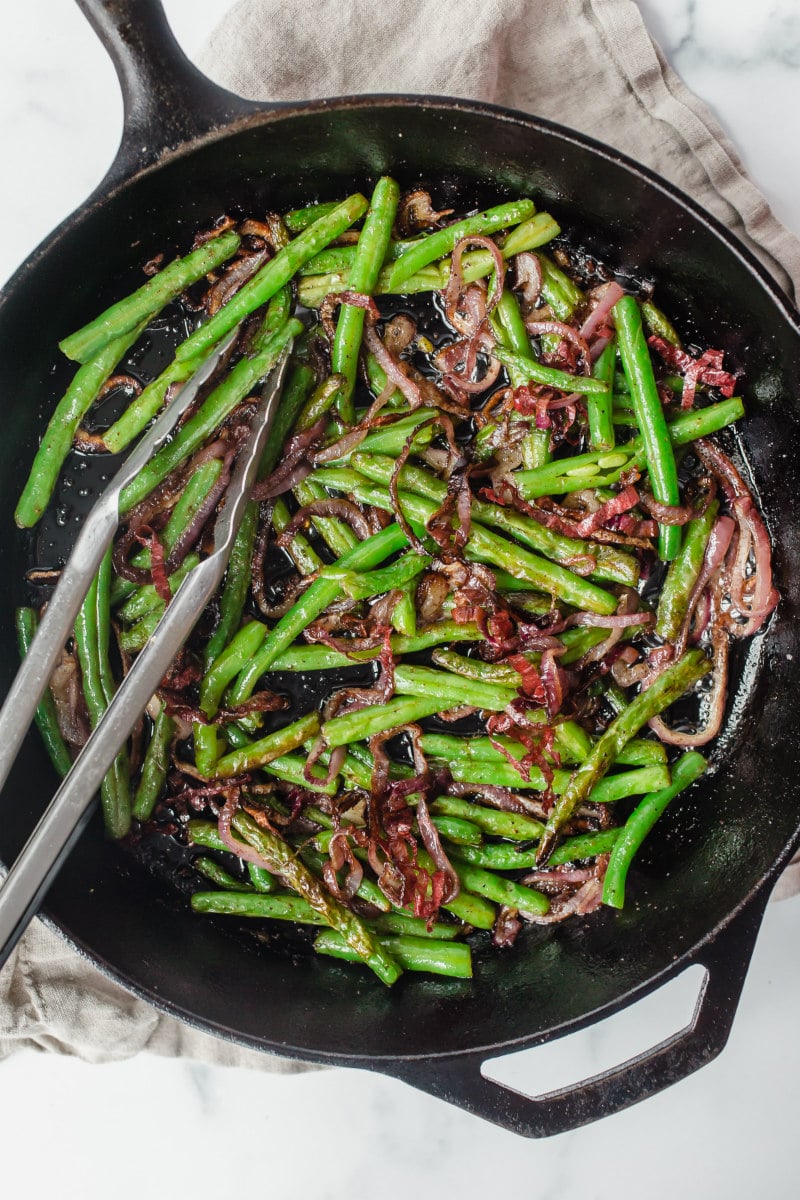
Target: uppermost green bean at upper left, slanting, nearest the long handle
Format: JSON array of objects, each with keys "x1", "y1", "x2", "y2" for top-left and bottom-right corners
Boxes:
[{"x1": 59, "y1": 229, "x2": 240, "y2": 362}]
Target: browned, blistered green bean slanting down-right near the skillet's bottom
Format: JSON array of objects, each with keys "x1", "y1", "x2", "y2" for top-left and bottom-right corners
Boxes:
[{"x1": 233, "y1": 811, "x2": 401, "y2": 984}]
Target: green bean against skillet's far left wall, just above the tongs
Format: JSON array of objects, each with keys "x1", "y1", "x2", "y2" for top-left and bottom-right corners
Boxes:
[{"x1": 14, "y1": 325, "x2": 144, "y2": 529}]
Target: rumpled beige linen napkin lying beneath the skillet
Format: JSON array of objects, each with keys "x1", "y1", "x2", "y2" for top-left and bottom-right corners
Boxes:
[{"x1": 0, "y1": 0, "x2": 800, "y2": 1070}]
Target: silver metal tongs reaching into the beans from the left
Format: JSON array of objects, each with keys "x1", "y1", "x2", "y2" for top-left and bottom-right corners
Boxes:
[{"x1": 0, "y1": 334, "x2": 291, "y2": 966}]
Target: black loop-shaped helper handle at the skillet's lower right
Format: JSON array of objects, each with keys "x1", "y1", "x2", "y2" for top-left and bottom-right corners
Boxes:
[{"x1": 377, "y1": 888, "x2": 769, "y2": 1138}]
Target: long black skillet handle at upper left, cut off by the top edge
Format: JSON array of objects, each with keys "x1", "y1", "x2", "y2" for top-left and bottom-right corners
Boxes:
[{"x1": 78, "y1": 0, "x2": 275, "y2": 192}]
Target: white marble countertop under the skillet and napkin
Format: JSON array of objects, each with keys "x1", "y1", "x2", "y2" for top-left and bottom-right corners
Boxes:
[{"x1": 0, "y1": 0, "x2": 800, "y2": 1200}]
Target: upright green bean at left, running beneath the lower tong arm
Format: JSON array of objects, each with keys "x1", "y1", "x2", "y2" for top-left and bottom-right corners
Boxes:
[{"x1": 74, "y1": 552, "x2": 131, "y2": 838}]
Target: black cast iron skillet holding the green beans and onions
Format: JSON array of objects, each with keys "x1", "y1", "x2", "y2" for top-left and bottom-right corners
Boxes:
[{"x1": 0, "y1": 0, "x2": 800, "y2": 1135}]
